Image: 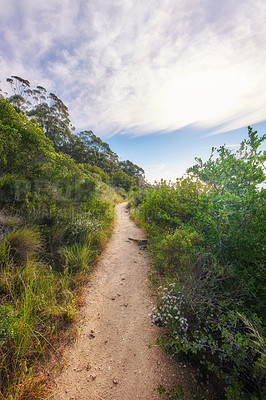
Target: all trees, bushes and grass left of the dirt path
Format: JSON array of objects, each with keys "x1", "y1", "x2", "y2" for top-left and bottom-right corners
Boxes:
[{"x1": 0, "y1": 77, "x2": 144, "y2": 400}]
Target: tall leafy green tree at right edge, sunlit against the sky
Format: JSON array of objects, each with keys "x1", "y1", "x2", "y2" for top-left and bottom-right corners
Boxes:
[{"x1": 188, "y1": 127, "x2": 266, "y2": 309}]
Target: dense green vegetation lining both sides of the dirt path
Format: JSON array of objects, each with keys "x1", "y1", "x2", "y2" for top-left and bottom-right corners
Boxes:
[{"x1": 0, "y1": 77, "x2": 266, "y2": 400}]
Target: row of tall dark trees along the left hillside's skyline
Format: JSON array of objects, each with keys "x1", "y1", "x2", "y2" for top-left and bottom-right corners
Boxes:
[{"x1": 0, "y1": 76, "x2": 146, "y2": 186}]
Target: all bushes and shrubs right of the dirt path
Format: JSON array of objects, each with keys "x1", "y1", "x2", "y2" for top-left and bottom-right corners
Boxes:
[{"x1": 131, "y1": 128, "x2": 266, "y2": 400}]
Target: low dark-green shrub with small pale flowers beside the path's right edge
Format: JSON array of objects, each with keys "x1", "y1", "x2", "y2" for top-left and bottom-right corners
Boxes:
[{"x1": 149, "y1": 283, "x2": 265, "y2": 400}]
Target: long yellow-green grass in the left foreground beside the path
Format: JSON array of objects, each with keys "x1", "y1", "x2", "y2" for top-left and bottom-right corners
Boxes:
[{"x1": 0, "y1": 249, "x2": 73, "y2": 399}]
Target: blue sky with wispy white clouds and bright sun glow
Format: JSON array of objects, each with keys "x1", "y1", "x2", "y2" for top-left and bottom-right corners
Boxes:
[{"x1": 0, "y1": 0, "x2": 266, "y2": 181}]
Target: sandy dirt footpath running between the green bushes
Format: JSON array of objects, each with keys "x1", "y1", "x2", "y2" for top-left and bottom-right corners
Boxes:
[{"x1": 51, "y1": 203, "x2": 185, "y2": 400}]
